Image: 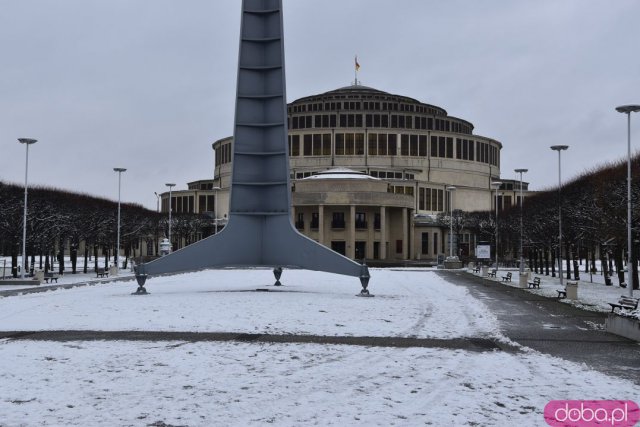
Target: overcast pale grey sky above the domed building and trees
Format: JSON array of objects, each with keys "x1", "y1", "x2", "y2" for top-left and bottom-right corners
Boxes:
[{"x1": 0, "y1": 0, "x2": 640, "y2": 209}]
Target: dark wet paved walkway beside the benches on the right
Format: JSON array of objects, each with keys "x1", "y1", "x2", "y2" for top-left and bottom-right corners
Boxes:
[{"x1": 439, "y1": 270, "x2": 640, "y2": 384}]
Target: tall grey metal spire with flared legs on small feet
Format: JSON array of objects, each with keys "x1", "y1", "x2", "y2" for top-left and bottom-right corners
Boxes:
[{"x1": 136, "y1": 0, "x2": 369, "y2": 296}]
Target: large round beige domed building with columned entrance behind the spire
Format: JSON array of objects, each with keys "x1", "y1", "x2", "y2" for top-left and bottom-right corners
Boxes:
[{"x1": 191, "y1": 85, "x2": 519, "y2": 261}]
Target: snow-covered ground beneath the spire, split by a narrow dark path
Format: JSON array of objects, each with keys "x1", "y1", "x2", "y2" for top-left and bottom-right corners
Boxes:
[{"x1": 0, "y1": 269, "x2": 640, "y2": 426}]
